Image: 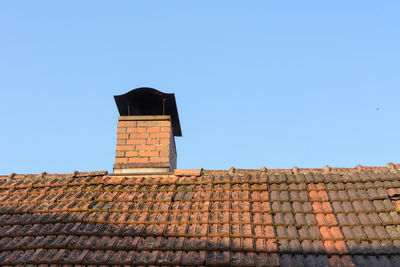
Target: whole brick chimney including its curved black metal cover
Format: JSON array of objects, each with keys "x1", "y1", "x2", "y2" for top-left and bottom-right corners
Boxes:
[{"x1": 113, "y1": 87, "x2": 182, "y2": 174}]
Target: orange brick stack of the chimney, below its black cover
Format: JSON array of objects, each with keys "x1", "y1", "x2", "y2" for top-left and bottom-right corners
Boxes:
[{"x1": 114, "y1": 115, "x2": 177, "y2": 173}]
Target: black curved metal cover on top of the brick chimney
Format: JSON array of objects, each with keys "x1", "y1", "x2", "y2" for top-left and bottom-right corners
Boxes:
[{"x1": 114, "y1": 87, "x2": 182, "y2": 136}]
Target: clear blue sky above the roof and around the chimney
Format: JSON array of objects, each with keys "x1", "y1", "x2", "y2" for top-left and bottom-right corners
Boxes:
[{"x1": 0, "y1": 0, "x2": 400, "y2": 174}]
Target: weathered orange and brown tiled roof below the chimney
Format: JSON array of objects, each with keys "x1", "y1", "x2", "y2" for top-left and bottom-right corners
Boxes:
[{"x1": 0, "y1": 164, "x2": 400, "y2": 266}]
